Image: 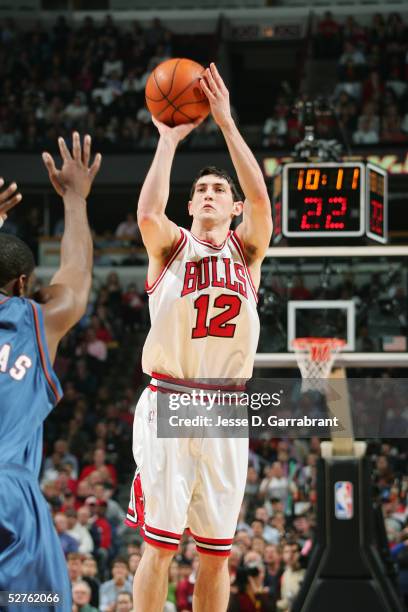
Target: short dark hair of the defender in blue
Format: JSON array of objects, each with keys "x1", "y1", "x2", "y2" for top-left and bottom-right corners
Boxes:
[{"x1": 0, "y1": 232, "x2": 35, "y2": 287}]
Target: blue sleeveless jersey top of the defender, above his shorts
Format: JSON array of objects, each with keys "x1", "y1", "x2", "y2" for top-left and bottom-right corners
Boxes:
[{"x1": 0, "y1": 295, "x2": 62, "y2": 478}]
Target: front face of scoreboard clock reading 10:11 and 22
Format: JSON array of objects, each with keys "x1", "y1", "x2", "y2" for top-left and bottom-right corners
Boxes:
[{"x1": 283, "y1": 162, "x2": 365, "y2": 237}]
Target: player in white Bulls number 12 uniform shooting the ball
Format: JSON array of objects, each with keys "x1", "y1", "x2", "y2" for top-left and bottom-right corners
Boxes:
[{"x1": 127, "y1": 64, "x2": 272, "y2": 612}]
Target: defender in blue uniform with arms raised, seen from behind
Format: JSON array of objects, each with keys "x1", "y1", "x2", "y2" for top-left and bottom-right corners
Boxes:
[{"x1": 0, "y1": 133, "x2": 101, "y2": 612}]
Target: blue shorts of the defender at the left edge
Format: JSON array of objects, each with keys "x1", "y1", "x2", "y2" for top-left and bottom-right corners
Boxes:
[{"x1": 0, "y1": 464, "x2": 72, "y2": 612}]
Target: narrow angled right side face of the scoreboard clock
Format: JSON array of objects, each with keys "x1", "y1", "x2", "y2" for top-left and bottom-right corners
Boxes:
[{"x1": 367, "y1": 164, "x2": 388, "y2": 243}]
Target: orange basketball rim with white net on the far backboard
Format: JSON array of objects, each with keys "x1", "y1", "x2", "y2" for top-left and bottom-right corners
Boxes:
[{"x1": 292, "y1": 338, "x2": 346, "y2": 393}]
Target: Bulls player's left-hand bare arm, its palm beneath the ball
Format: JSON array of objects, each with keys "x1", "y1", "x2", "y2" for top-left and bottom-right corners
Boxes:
[{"x1": 137, "y1": 117, "x2": 200, "y2": 262}]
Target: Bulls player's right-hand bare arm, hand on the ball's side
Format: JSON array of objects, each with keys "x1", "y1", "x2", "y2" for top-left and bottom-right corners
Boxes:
[{"x1": 201, "y1": 64, "x2": 272, "y2": 264}]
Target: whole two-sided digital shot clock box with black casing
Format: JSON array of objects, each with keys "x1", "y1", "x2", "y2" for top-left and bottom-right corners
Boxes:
[{"x1": 273, "y1": 162, "x2": 387, "y2": 242}]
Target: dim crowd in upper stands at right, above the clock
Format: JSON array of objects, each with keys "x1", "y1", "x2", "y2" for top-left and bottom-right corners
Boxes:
[{"x1": 263, "y1": 12, "x2": 408, "y2": 147}]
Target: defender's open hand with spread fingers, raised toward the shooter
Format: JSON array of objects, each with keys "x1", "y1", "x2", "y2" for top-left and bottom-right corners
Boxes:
[{"x1": 42, "y1": 132, "x2": 102, "y2": 199}]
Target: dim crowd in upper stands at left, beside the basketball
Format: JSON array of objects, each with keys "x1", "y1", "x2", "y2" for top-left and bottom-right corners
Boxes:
[{"x1": 0, "y1": 16, "x2": 214, "y2": 153}]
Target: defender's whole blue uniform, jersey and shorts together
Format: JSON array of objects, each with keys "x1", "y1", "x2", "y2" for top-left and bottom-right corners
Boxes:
[{"x1": 0, "y1": 296, "x2": 72, "y2": 612}]
